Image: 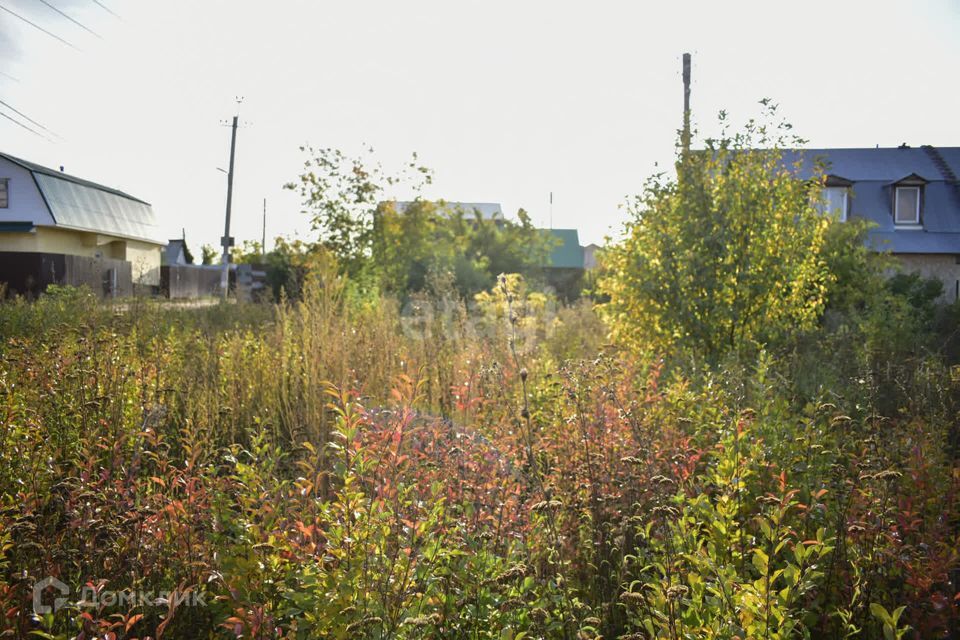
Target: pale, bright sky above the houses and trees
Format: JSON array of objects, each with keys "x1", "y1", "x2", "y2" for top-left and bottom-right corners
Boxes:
[{"x1": 0, "y1": 0, "x2": 960, "y2": 248}]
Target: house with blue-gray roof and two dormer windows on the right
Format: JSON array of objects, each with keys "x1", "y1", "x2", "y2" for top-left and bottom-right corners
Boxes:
[{"x1": 784, "y1": 145, "x2": 960, "y2": 302}]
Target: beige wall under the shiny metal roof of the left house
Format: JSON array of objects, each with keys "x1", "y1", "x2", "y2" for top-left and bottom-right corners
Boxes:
[{"x1": 0, "y1": 227, "x2": 161, "y2": 286}]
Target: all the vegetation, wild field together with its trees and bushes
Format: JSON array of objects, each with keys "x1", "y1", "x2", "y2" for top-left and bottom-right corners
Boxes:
[{"x1": 0, "y1": 126, "x2": 960, "y2": 640}]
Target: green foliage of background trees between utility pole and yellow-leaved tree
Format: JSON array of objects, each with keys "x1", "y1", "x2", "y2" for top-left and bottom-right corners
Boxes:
[{"x1": 287, "y1": 148, "x2": 550, "y2": 299}]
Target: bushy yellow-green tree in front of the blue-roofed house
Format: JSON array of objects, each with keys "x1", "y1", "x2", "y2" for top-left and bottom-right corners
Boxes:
[{"x1": 599, "y1": 102, "x2": 835, "y2": 362}]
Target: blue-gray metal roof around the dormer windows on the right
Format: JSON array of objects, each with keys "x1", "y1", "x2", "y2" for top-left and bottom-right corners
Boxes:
[{"x1": 783, "y1": 147, "x2": 960, "y2": 254}]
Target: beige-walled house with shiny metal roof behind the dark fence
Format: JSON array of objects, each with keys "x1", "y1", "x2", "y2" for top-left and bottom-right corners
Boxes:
[{"x1": 0, "y1": 153, "x2": 166, "y2": 295}]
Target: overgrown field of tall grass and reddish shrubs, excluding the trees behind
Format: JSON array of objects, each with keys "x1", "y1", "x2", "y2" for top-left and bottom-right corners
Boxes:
[{"x1": 0, "y1": 269, "x2": 960, "y2": 640}]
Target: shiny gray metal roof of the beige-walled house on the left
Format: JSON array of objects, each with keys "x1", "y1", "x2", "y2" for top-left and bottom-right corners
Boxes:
[{"x1": 0, "y1": 153, "x2": 166, "y2": 244}]
